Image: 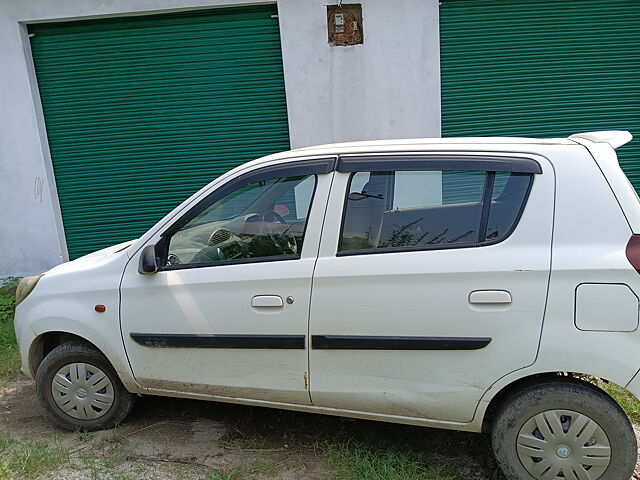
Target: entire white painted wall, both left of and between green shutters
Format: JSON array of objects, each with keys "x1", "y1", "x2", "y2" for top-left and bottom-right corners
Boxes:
[{"x1": 0, "y1": 0, "x2": 440, "y2": 278}]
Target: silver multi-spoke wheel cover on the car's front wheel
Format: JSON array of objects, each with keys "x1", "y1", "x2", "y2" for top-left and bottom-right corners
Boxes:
[{"x1": 51, "y1": 363, "x2": 114, "y2": 420}]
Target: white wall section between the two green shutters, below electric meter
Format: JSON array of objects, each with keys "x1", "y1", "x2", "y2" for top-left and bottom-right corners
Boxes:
[{"x1": 279, "y1": 0, "x2": 440, "y2": 148}]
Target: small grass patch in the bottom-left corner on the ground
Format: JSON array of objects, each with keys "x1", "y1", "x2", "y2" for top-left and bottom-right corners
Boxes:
[{"x1": 0, "y1": 433, "x2": 69, "y2": 479}]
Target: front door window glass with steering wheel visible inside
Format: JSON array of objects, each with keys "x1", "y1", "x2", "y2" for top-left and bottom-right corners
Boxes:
[{"x1": 166, "y1": 175, "x2": 316, "y2": 268}]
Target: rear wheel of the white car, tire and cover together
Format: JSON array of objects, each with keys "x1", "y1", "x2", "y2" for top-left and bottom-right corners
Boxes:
[{"x1": 491, "y1": 380, "x2": 637, "y2": 480}]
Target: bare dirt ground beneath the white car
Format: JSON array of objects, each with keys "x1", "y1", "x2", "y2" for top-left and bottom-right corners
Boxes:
[{"x1": 0, "y1": 379, "x2": 640, "y2": 480}]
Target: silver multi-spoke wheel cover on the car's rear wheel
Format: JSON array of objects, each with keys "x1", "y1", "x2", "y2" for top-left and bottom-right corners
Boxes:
[{"x1": 517, "y1": 410, "x2": 611, "y2": 480}]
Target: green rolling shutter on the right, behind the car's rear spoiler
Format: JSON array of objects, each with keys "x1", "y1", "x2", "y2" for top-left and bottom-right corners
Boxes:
[{"x1": 440, "y1": 0, "x2": 640, "y2": 191}]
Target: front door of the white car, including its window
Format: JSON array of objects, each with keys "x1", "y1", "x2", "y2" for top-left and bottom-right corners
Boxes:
[{"x1": 121, "y1": 159, "x2": 335, "y2": 405}]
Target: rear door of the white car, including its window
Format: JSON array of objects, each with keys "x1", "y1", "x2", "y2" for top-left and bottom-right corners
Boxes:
[{"x1": 309, "y1": 154, "x2": 554, "y2": 423}]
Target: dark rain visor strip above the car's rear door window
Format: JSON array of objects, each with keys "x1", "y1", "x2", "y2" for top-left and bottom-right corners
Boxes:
[{"x1": 337, "y1": 153, "x2": 542, "y2": 174}]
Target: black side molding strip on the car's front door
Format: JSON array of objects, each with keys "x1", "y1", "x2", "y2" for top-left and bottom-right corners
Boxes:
[{"x1": 129, "y1": 333, "x2": 305, "y2": 350}]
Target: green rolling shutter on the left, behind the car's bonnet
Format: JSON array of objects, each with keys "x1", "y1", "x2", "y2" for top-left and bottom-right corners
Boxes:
[{"x1": 29, "y1": 5, "x2": 289, "y2": 259}]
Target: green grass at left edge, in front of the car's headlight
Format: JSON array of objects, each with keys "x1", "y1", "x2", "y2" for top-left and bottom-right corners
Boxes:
[{"x1": 0, "y1": 277, "x2": 20, "y2": 387}]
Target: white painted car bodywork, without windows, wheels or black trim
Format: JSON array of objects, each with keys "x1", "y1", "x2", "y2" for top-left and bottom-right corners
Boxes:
[{"x1": 15, "y1": 132, "x2": 640, "y2": 431}]
